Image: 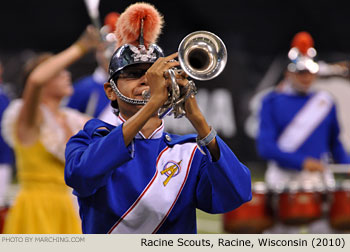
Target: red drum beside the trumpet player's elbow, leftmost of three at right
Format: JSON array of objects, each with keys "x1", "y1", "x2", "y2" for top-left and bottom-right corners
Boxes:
[{"x1": 223, "y1": 182, "x2": 273, "y2": 234}]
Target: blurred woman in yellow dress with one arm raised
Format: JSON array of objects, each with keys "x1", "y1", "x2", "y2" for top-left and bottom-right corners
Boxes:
[{"x1": 3, "y1": 27, "x2": 100, "y2": 234}]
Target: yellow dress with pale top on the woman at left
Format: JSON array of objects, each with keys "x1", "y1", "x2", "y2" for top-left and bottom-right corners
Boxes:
[{"x1": 2, "y1": 100, "x2": 85, "y2": 234}]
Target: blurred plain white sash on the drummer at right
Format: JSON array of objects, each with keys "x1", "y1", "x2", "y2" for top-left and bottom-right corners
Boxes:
[{"x1": 277, "y1": 92, "x2": 333, "y2": 152}]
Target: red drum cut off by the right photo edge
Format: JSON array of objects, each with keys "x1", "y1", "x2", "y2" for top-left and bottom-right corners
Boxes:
[{"x1": 329, "y1": 180, "x2": 350, "y2": 230}]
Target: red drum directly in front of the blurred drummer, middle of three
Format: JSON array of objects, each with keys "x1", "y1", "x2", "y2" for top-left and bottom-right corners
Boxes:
[{"x1": 277, "y1": 182, "x2": 324, "y2": 225}]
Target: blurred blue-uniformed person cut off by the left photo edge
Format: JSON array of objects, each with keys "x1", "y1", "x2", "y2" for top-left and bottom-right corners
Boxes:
[{"x1": 0, "y1": 61, "x2": 14, "y2": 234}]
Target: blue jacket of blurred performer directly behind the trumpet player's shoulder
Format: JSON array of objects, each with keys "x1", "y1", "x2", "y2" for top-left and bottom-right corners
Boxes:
[{"x1": 67, "y1": 67, "x2": 110, "y2": 118}]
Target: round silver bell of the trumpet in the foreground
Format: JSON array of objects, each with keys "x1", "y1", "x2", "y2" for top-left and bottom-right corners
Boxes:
[{"x1": 178, "y1": 31, "x2": 227, "y2": 81}]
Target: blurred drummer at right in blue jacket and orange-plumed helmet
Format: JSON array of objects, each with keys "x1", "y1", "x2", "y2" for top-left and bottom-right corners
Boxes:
[{"x1": 257, "y1": 32, "x2": 350, "y2": 232}]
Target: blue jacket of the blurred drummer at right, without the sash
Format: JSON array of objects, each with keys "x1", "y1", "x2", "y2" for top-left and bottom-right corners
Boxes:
[{"x1": 257, "y1": 91, "x2": 350, "y2": 170}]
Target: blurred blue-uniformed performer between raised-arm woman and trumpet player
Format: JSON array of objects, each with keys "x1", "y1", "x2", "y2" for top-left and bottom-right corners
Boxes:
[{"x1": 67, "y1": 12, "x2": 119, "y2": 118}]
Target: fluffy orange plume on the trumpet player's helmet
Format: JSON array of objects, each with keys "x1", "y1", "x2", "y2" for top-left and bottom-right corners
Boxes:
[{"x1": 115, "y1": 2, "x2": 163, "y2": 48}]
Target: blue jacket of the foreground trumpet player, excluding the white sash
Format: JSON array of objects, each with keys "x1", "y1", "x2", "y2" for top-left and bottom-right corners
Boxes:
[{"x1": 65, "y1": 119, "x2": 251, "y2": 233}]
